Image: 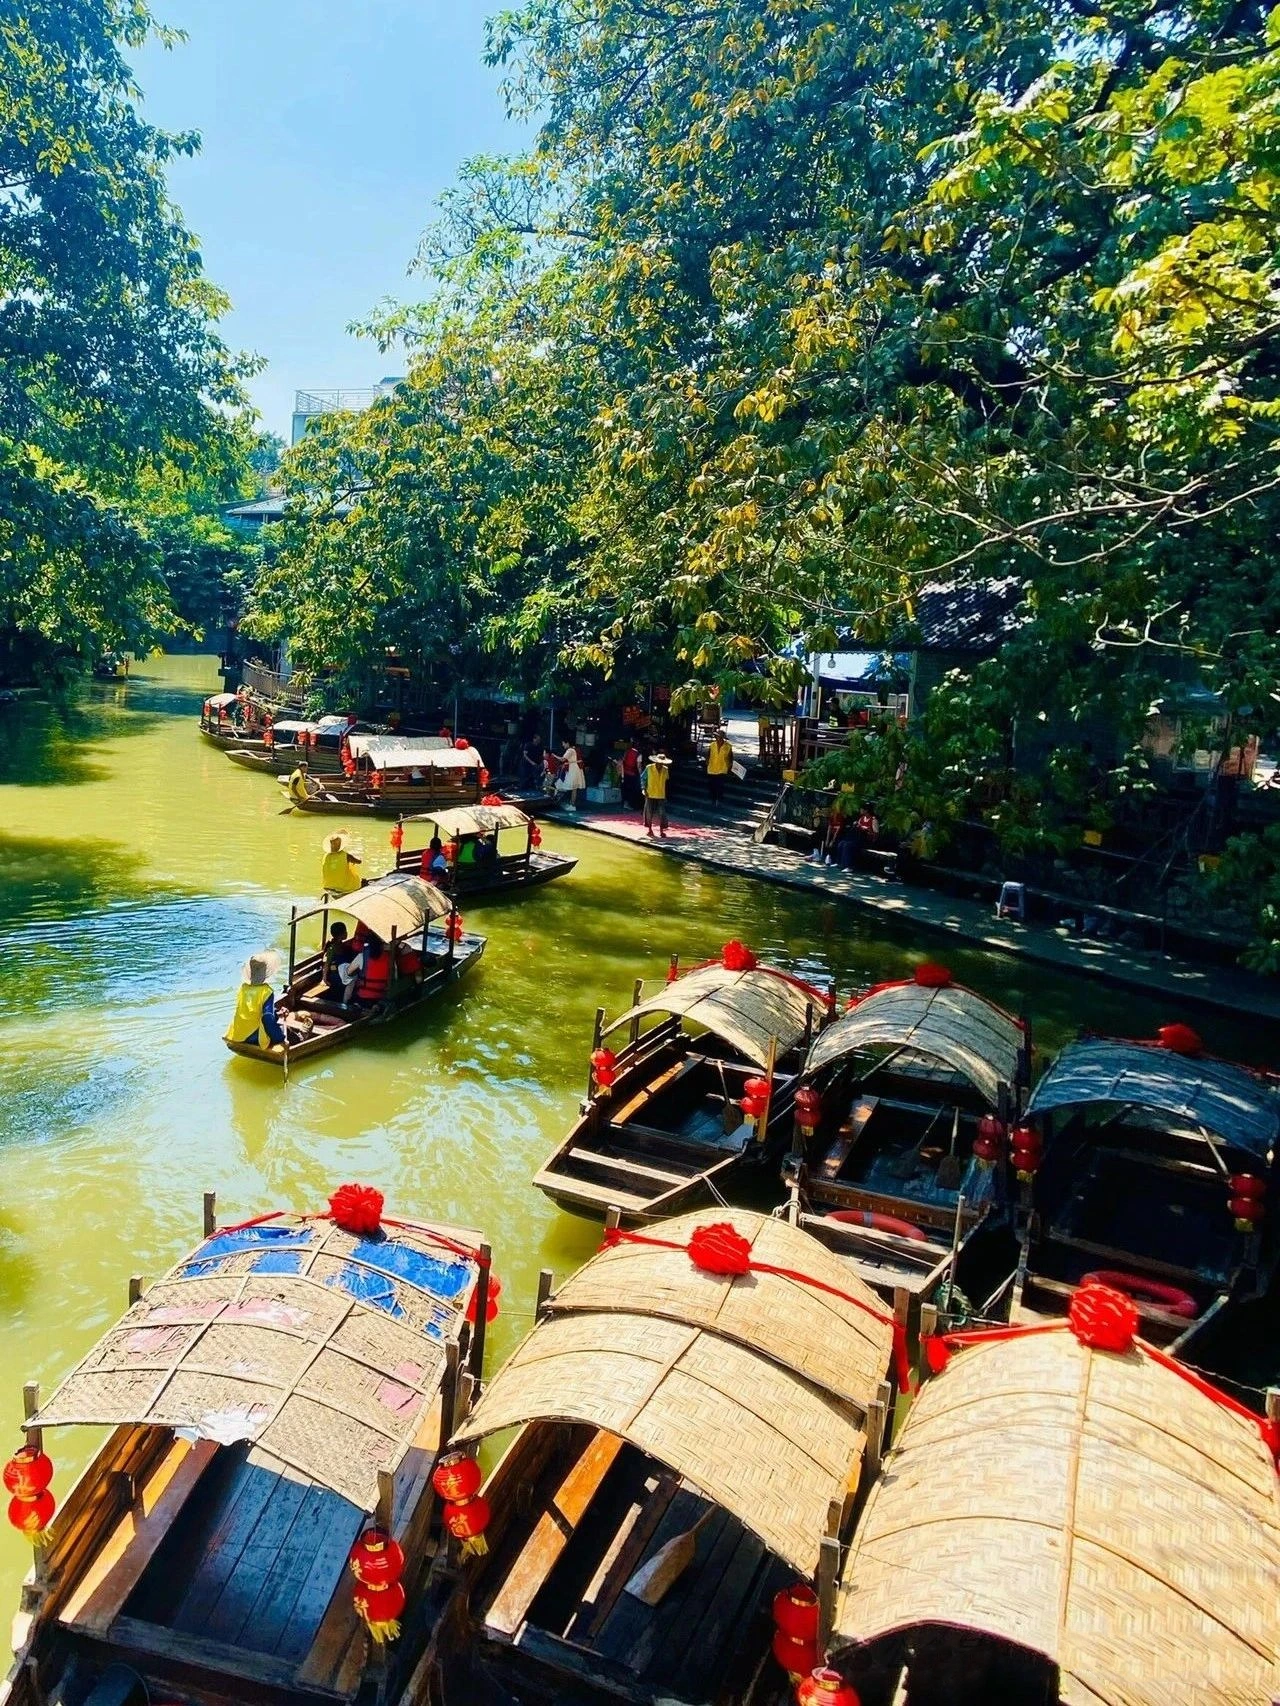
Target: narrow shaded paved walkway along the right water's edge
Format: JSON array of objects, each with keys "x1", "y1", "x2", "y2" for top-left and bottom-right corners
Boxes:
[{"x1": 573, "y1": 807, "x2": 1280, "y2": 1022}]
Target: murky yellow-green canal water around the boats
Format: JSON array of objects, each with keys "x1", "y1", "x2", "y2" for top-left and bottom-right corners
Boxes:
[{"x1": 0, "y1": 657, "x2": 1269, "y2": 1596}]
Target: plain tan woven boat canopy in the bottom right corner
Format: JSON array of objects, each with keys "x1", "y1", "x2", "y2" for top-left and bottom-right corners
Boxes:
[{"x1": 835, "y1": 1332, "x2": 1280, "y2": 1706}]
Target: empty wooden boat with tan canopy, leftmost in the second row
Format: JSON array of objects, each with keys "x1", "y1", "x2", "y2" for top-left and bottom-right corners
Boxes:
[{"x1": 534, "y1": 942, "x2": 831, "y2": 1223}]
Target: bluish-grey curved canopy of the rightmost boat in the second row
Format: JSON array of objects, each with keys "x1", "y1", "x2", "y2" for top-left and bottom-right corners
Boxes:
[{"x1": 1027, "y1": 1039, "x2": 1280, "y2": 1155}]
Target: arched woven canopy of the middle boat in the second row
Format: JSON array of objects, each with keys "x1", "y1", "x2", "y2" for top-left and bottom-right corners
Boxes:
[{"x1": 804, "y1": 983, "x2": 1026, "y2": 1107}]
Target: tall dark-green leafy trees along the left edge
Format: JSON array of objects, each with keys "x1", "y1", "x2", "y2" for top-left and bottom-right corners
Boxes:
[{"x1": 0, "y1": 0, "x2": 256, "y2": 682}]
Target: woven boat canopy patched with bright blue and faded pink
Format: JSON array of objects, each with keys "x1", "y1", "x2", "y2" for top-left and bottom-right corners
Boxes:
[{"x1": 31, "y1": 1218, "x2": 481, "y2": 1510}]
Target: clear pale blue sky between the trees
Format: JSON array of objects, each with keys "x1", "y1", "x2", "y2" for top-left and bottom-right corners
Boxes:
[{"x1": 137, "y1": 0, "x2": 524, "y2": 438}]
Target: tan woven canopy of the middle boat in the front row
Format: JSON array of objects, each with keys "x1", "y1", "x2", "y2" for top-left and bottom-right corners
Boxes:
[{"x1": 457, "y1": 1210, "x2": 893, "y2": 1575}]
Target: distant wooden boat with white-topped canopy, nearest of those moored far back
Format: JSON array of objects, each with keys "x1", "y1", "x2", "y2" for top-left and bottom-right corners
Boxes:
[{"x1": 280, "y1": 734, "x2": 488, "y2": 817}]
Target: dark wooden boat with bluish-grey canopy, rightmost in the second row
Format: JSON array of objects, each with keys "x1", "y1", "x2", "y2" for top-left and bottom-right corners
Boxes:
[{"x1": 1012, "y1": 1027, "x2": 1280, "y2": 1367}]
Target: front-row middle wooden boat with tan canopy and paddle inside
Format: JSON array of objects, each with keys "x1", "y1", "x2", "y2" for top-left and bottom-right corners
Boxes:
[{"x1": 431, "y1": 1210, "x2": 893, "y2": 1706}]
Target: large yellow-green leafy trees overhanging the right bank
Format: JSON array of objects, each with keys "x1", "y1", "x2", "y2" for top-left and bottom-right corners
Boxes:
[{"x1": 247, "y1": 0, "x2": 1280, "y2": 969}]
